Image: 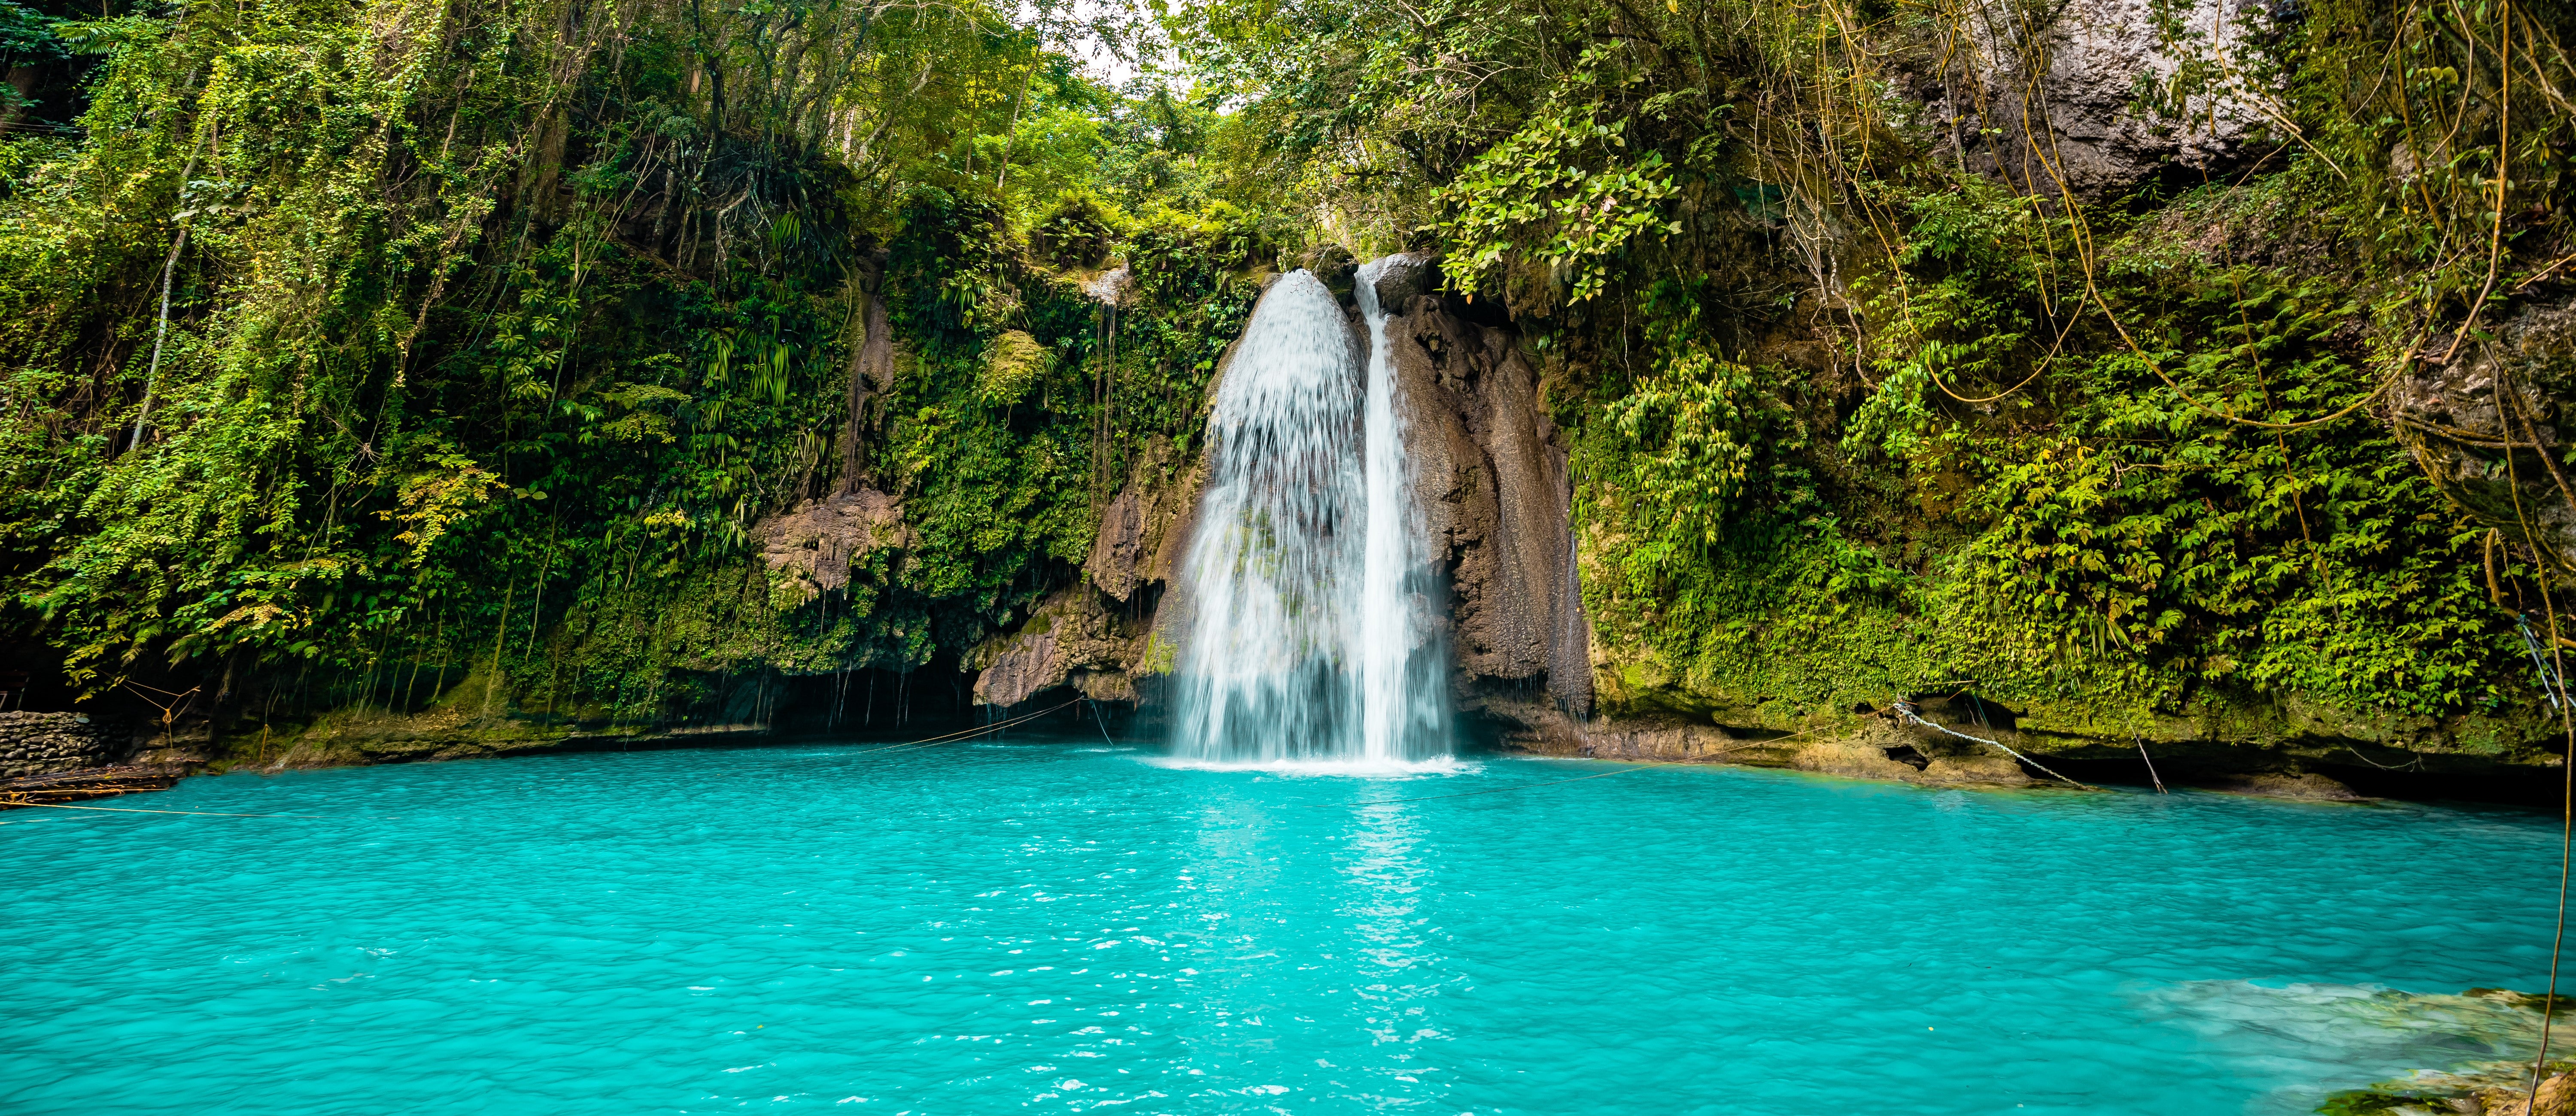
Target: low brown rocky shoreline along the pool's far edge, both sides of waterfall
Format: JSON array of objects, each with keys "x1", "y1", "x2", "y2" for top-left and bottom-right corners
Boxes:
[{"x1": 0, "y1": 688, "x2": 2566, "y2": 807}]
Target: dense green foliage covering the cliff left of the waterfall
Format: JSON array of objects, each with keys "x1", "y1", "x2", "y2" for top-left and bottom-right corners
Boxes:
[{"x1": 0, "y1": 0, "x2": 1278, "y2": 716}]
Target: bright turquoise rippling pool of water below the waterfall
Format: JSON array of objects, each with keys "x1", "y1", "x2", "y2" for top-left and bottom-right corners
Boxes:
[{"x1": 0, "y1": 737, "x2": 2555, "y2": 1116}]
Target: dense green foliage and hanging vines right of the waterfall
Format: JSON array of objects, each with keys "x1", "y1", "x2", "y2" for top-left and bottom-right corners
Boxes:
[{"x1": 1190, "y1": 0, "x2": 2576, "y2": 722}]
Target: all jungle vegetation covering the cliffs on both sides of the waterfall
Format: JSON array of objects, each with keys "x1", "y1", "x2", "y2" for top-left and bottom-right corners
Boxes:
[{"x1": 0, "y1": 0, "x2": 2576, "y2": 742}]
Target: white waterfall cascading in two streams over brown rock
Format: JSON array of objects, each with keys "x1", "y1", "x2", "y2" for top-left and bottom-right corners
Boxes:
[{"x1": 1172, "y1": 260, "x2": 1448, "y2": 768}]
